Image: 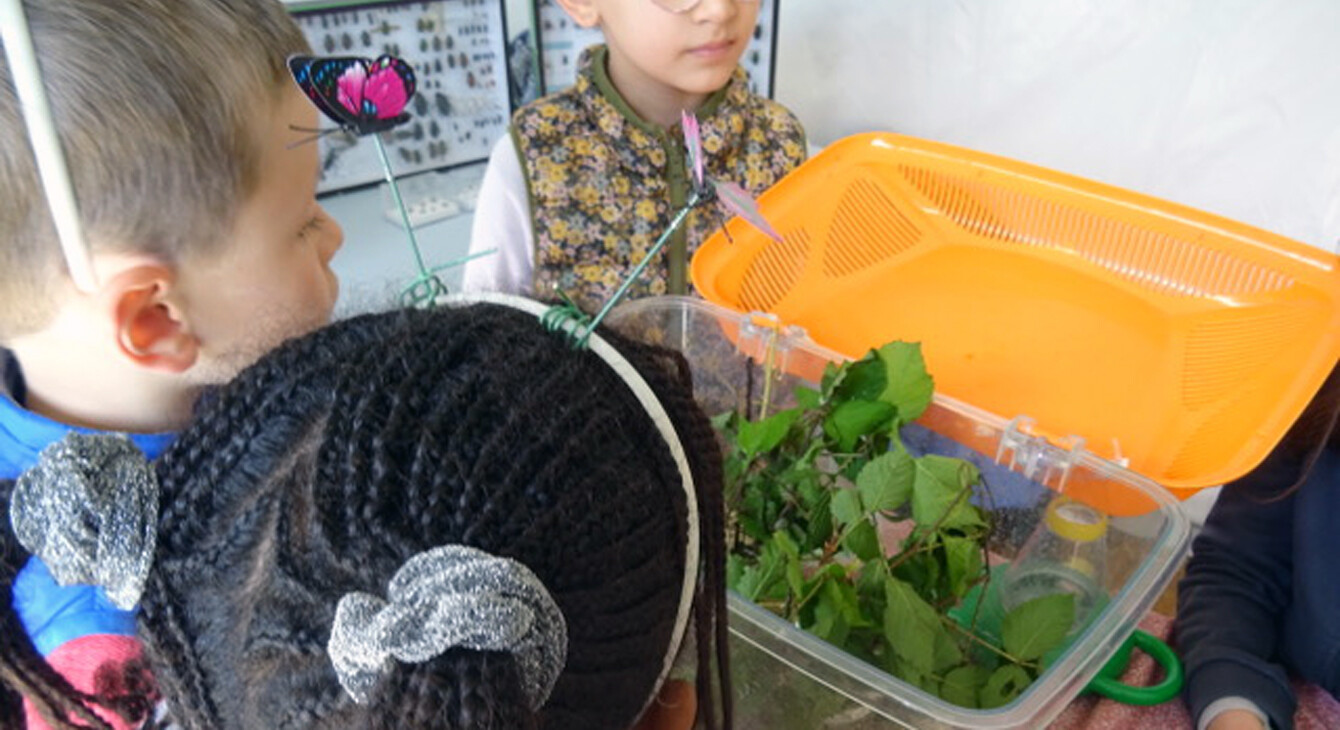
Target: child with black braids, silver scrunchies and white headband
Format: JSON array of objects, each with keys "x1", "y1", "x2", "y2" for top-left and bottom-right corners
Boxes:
[{"x1": 11, "y1": 295, "x2": 730, "y2": 730}]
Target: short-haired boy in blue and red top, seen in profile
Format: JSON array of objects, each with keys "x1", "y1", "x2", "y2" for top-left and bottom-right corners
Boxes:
[{"x1": 0, "y1": 0, "x2": 343, "y2": 727}]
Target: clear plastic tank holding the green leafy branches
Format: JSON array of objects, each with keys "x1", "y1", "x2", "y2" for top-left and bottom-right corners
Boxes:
[{"x1": 607, "y1": 296, "x2": 1190, "y2": 730}]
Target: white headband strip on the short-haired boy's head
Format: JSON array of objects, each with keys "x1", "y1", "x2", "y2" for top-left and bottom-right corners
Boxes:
[{"x1": 0, "y1": 0, "x2": 98, "y2": 292}]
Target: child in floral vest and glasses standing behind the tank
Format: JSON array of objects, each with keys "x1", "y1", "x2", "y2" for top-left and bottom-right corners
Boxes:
[{"x1": 464, "y1": 0, "x2": 805, "y2": 312}]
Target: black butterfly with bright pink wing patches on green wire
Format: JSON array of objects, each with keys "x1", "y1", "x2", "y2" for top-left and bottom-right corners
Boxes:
[{"x1": 288, "y1": 56, "x2": 415, "y2": 137}]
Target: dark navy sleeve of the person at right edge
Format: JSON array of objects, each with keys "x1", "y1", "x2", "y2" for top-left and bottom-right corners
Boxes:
[{"x1": 1175, "y1": 469, "x2": 1297, "y2": 729}]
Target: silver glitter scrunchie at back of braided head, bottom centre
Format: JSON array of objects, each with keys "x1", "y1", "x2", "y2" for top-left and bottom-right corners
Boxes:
[{"x1": 333, "y1": 545, "x2": 568, "y2": 709}]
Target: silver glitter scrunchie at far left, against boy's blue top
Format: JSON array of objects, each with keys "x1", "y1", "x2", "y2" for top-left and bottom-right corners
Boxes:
[{"x1": 9, "y1": 433, "x2": 158, "y2": 611}]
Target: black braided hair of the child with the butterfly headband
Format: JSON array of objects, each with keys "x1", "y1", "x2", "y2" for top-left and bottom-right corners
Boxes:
[{"x1": 141, "y1": 298, "x2": 730, "y2": 730}]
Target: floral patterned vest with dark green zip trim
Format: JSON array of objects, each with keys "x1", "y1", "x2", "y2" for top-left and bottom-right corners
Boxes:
[{"x1": 512, "y1": 46, "x2": 805, "y2": 312}]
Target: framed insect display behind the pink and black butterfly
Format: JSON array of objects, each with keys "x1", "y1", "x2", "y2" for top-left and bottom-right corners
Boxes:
[{"x1": 288, "y1": 0, "x2": 512, "y2": 193}]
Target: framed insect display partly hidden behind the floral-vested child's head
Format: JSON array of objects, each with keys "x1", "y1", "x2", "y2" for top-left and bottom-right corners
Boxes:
[{"x1": 532, "y1": 0, "x2": 779, "y2": 99}]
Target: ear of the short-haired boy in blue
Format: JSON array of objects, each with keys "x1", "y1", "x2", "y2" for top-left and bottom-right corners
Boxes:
[{"x1": 103, "y1": 264, "x2": 200, "y2": 372}]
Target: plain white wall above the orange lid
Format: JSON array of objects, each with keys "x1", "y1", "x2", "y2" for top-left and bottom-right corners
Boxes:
[{"x1": 776, "y1": 0, "x2": 1340, "y2": 250}]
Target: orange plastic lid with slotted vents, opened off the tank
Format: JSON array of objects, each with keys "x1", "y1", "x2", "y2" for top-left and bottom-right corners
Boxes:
[{"x1": 691, "y1": 134, "x2": 1340, "y2": 497}]
